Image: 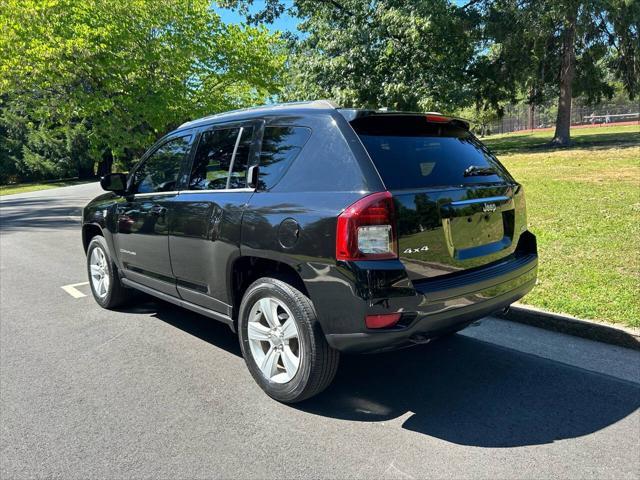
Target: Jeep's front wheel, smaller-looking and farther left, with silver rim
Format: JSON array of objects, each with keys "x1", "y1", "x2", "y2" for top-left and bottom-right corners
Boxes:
[{"x1": 87, "y1": 235, "x2": 130, "y2": 308}]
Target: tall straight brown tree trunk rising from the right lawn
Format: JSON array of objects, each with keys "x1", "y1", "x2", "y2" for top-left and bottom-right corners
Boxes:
[{"x1": 551, "y1": 2, "x2": 578, "y2": 146}]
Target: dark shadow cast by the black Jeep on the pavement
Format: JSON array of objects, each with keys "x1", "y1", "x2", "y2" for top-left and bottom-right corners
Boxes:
[{"x1": 121, "y1": 300, "x2": 640, "y2": 448}]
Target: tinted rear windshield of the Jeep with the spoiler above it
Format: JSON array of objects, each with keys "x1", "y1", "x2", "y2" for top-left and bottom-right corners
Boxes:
[{"x1": 351, "y1": 115, "x2": 513, "y2": 189}]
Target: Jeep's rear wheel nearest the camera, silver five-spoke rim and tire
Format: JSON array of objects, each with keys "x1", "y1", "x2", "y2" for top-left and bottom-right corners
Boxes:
[{"x1": 238, "y1": 278, "x2": 339, "y2": 403}]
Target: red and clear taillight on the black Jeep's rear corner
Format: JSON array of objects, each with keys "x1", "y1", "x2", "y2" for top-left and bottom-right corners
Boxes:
[{"x1": 336, "y1": 192, "x2": 398, "y2": 261}]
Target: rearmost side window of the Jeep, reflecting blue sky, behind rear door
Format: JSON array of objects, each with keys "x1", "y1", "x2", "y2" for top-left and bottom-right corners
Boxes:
[{"x1": 260, "y1": 127, "x2": 311, "y2": 190}]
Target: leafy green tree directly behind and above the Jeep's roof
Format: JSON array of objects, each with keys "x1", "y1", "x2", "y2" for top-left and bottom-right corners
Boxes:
[{"x1": 221, "y1": 0, "x2": 477, "y2": 110}]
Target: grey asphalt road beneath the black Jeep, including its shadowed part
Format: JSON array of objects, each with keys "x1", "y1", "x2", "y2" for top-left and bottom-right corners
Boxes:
[{"x1": 0, "y1": 184, "x2": 640, "y2": 479}]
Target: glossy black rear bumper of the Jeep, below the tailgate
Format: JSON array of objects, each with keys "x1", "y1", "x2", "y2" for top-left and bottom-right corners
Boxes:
[{"x1": 323, "y1": 254, "x2": 538, "y2": 352}]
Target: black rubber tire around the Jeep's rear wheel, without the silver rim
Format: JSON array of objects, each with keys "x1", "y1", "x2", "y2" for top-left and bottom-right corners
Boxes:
[{"x1": 238, "y1": 277, "x2": 340, "y2": 403}]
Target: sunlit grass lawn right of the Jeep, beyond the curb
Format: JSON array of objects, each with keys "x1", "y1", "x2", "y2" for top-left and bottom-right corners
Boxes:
[{"x1": 483, "y1": 126, "x2": 640, "y2": 327}]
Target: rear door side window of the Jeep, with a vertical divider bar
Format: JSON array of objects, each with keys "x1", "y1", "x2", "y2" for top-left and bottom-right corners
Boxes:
[{"x1": 189, "y1": 127, "x2": 252, "y2": 190}]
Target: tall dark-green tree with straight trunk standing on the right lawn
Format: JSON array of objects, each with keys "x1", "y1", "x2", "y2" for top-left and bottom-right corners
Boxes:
[{"x1": 472, "y1": 0, "x2": 640, "y2": 145}]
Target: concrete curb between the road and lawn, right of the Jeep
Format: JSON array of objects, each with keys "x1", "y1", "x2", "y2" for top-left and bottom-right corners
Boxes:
[{"x1": 498, "y1": 304, "x2": 640, "y2": 350}]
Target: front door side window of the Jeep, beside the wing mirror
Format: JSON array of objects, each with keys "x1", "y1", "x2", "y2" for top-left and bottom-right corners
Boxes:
[{"x1": 133, "y1": 135, "x2": 191, "y2": 193}]
